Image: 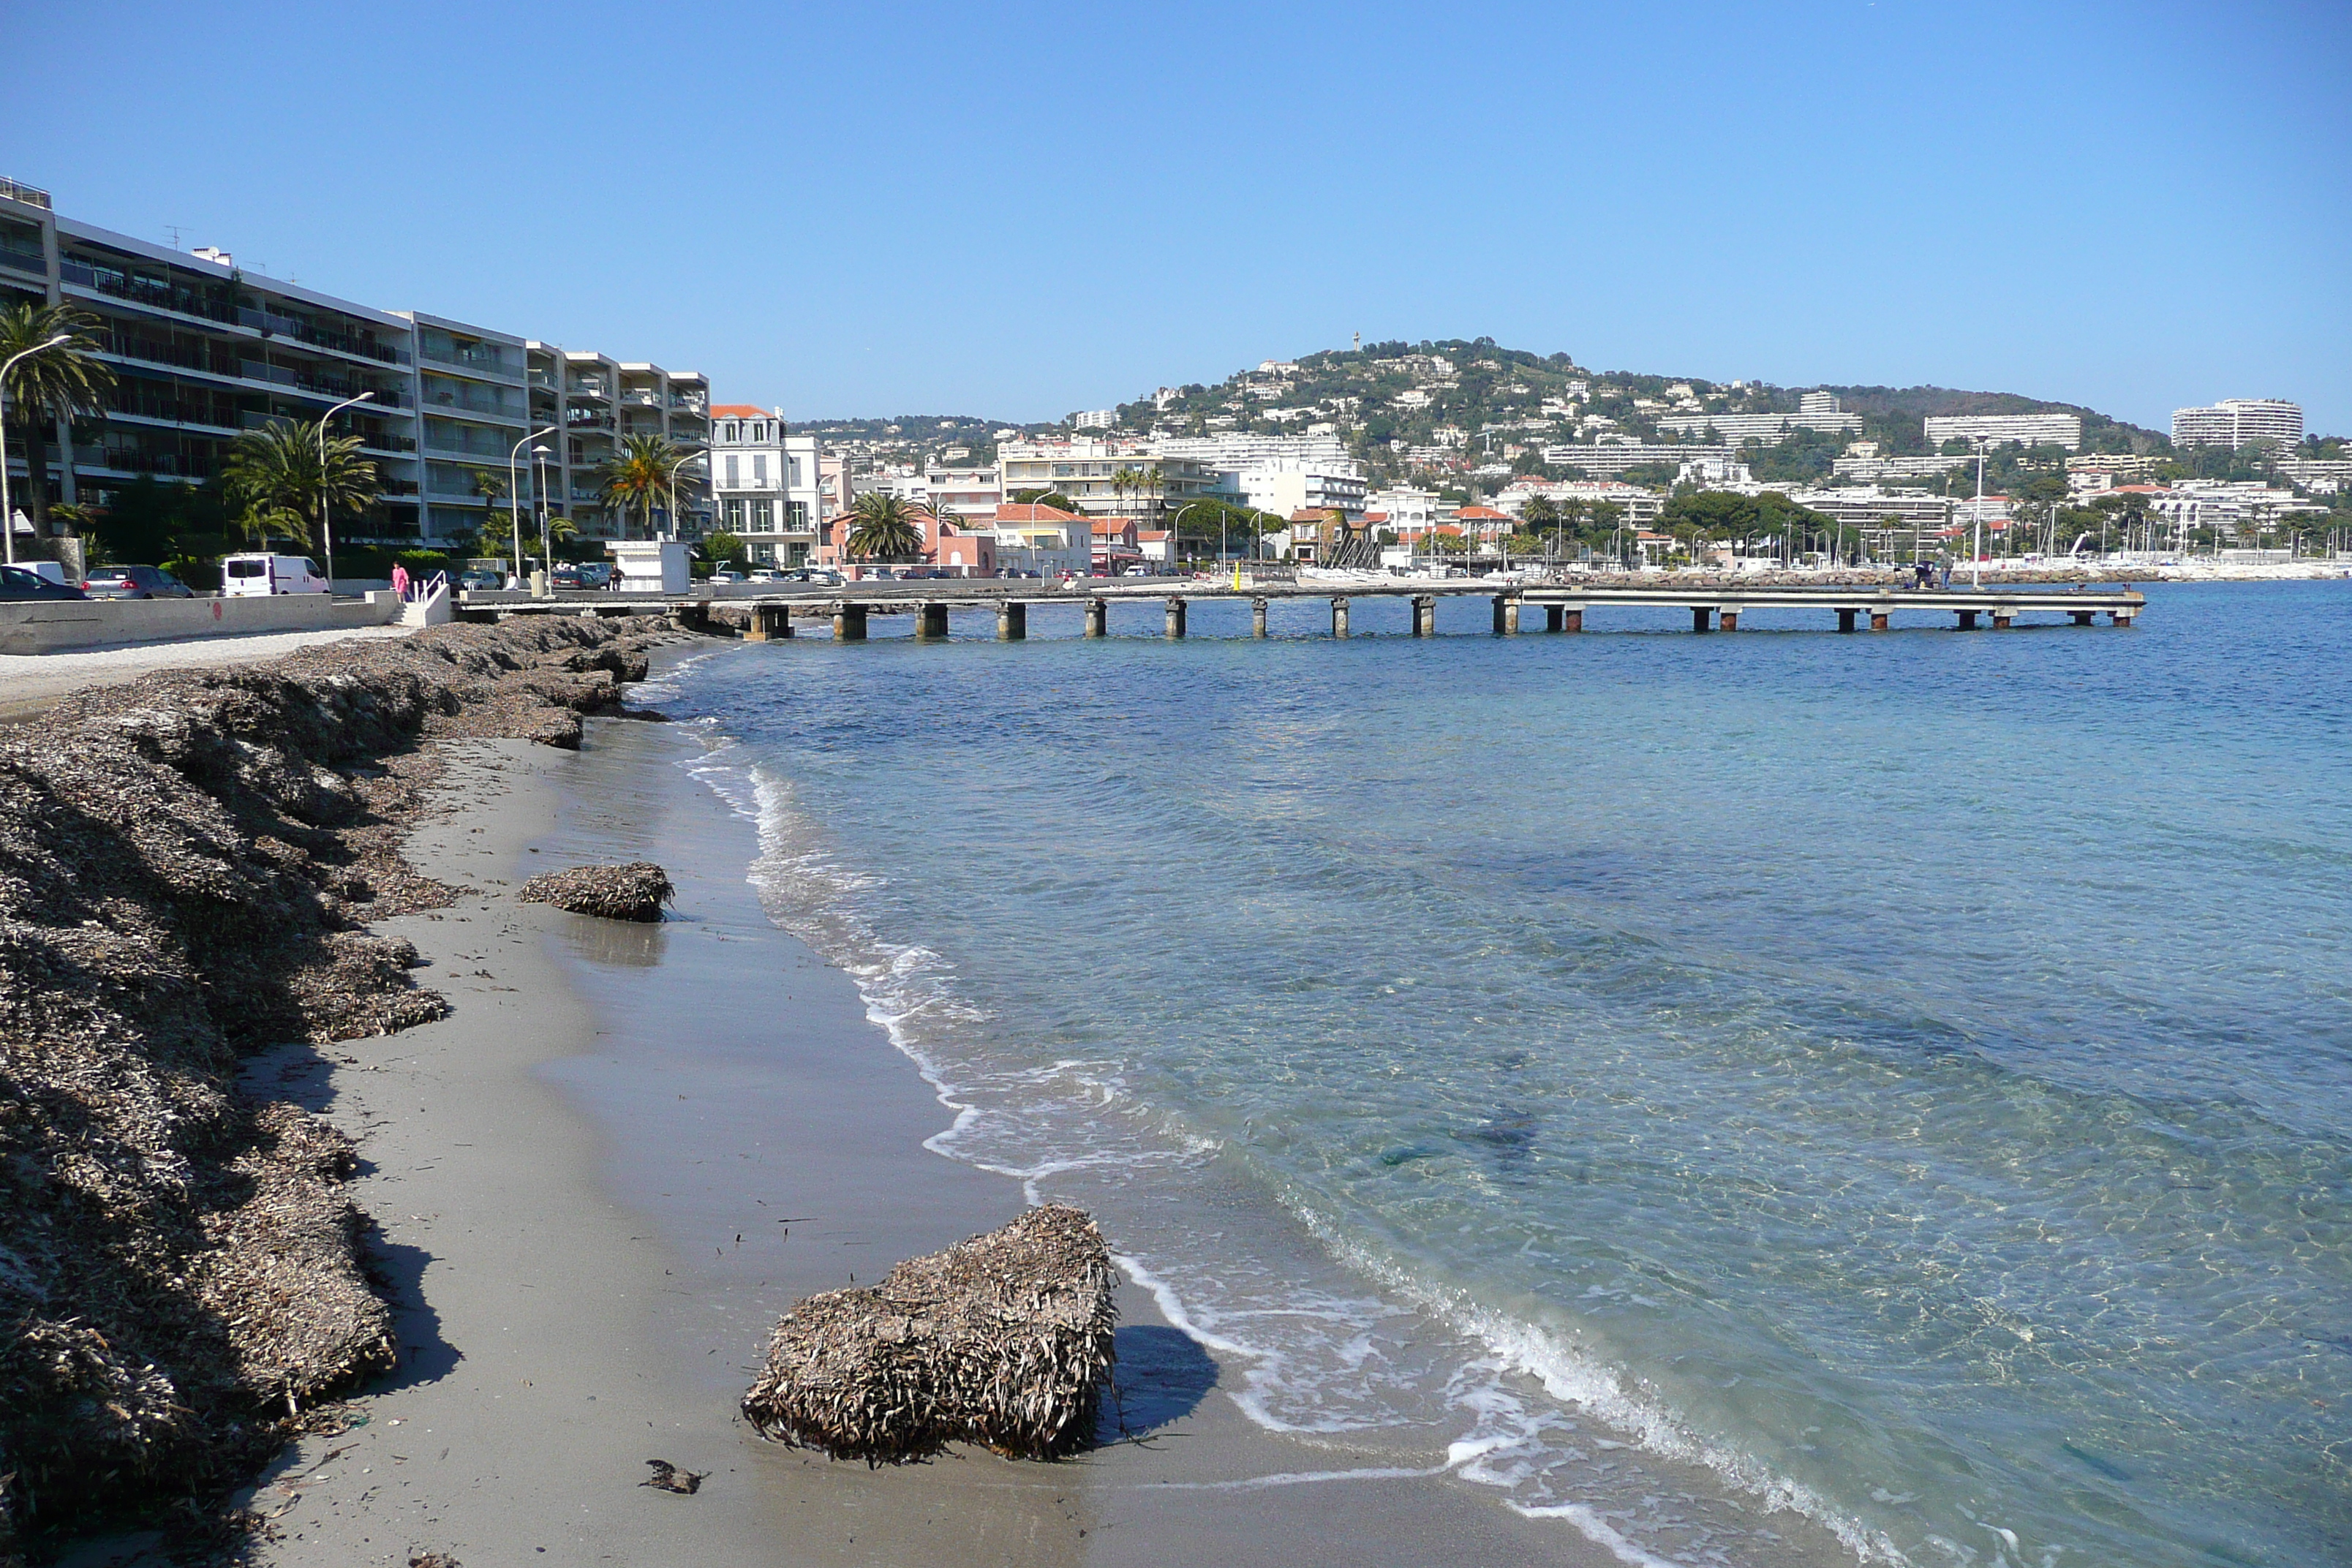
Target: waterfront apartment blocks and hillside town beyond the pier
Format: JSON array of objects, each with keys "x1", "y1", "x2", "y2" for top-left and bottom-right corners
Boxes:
[{"x1": 13, "y1": 181, "x2": 2352, "y2": 581}]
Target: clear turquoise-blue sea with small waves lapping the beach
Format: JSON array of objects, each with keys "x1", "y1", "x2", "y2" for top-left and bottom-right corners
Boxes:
[{"x1": 663, "y1": 583, "x2": 2352, "y2": 1566}]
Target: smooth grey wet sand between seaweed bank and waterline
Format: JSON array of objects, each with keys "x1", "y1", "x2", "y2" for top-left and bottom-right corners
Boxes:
[{"x1": 221, "y1": 691, "x2": 1646, "y2": 1568}]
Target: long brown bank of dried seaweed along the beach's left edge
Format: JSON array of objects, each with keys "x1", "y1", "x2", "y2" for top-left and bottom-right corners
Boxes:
[{"x1": 0, "y1": 621, "x2": 675, "y2": 1561}]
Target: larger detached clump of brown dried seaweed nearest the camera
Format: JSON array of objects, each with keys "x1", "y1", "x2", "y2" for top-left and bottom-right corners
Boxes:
[{"x1": 743, "y1": 1204, "x2": 1120, "y2": 1465}]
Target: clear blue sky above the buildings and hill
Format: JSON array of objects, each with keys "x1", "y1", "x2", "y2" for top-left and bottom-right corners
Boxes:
[{"x1": 0, "y1": 0, "x2": 2352, "y2": 432}]
